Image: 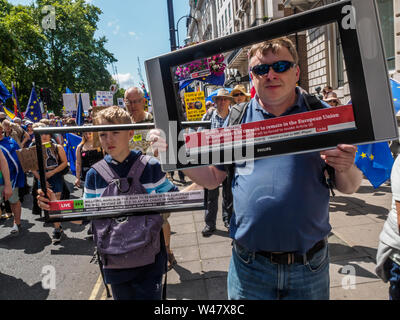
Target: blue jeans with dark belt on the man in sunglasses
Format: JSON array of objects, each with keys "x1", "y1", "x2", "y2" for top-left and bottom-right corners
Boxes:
[{"x1": 228, "y1": 240, "x2": 329, "y2": 300}]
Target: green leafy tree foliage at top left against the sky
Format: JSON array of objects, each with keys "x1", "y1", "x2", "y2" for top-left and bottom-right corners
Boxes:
[{"x1": 0, "y1": 0, "x2": 116, "y2": 113}]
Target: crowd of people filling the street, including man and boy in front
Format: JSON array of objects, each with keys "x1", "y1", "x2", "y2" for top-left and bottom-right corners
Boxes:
[{"x1": 0, "y1": 38, "x2": 400, "y2": 300}]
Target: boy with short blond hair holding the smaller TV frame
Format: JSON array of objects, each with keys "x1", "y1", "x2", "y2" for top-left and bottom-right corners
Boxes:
[{"x1": 38, "y1": 106, "x2": 178, "y2": 300}]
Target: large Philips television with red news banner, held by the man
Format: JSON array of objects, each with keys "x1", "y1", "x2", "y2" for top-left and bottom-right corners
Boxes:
[{"x1": 145, "y1": 0, "x2": 398, "y2": 171}]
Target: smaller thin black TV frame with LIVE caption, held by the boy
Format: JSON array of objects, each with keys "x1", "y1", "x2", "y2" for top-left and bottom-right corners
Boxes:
[{"x1": 32, "y1": 123, "x2": 207, "y2": 222}]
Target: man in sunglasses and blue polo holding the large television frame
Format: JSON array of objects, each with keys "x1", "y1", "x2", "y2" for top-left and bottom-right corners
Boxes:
[{"x1": 151, "y1": 38, "x2": 362, "y2": 299}]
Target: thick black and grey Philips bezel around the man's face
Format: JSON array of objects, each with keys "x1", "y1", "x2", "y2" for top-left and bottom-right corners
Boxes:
[{"x1": 145, "y1": 0, "x2": 398, "y2": 171}]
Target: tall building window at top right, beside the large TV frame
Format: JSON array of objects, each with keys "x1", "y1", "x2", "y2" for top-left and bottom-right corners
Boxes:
[{"x1": 377, "y1": 0, "x2": 395, "y2": 70}]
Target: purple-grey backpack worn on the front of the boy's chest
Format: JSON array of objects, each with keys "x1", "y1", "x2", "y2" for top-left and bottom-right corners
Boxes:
[{"x1": 92, "y1": 155, "x2": 163, "y2": 269}]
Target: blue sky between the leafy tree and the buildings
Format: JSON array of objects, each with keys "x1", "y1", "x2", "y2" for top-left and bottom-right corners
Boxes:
[{"x1": 9, "y1": 0, "x2": 189, "y2": 89}]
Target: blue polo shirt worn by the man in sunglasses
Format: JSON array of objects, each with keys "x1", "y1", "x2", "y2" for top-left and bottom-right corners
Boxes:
[{"x1": 217, "y1": 91, "x2": 331, "y2": 253}]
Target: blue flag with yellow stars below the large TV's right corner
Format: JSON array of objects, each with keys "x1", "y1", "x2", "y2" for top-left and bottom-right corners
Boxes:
[{"x1": 355, "y1": 142, "x2": 394, "y2": 189}]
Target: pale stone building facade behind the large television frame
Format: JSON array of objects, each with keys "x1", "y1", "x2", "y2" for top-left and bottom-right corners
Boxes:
[{"x1": 188, "y1": 0, "x2": 400, "y2": 102}]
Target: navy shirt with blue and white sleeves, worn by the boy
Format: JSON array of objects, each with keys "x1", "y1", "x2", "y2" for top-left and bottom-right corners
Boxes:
[{"x1": 83, "y1": 150, "x2": 179, "y2": 284}]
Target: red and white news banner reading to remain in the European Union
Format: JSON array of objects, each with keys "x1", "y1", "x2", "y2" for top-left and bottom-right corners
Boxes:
[{"x1": 185, "y1": 105, "x2": 355, "y2": 154}]
